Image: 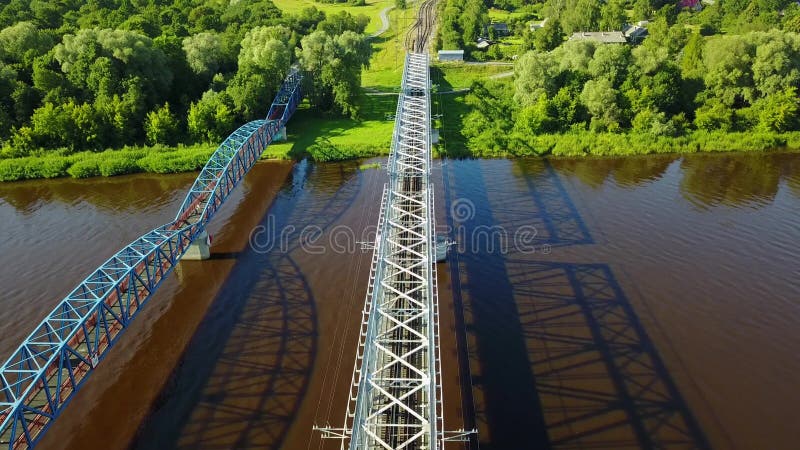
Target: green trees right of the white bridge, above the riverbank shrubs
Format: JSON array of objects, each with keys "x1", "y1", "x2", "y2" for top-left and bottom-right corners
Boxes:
[{"x1": 456, "y1": 0, "x2": 800, "y2": 152}]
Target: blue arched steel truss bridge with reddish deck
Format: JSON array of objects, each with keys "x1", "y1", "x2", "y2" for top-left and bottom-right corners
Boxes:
[{"x1": 0, "y1": 68, "x2": 302, "y2": 450}]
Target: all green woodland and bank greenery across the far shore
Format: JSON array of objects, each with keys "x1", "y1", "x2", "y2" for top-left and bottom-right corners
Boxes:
[{"x1": 0, "y1": 0, "x2": 800, "y2": 180}]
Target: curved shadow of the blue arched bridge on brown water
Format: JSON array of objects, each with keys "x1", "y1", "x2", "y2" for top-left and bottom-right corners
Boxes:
[{"x1": 131, "y1": 162, "x2": 361, "y2": 449}]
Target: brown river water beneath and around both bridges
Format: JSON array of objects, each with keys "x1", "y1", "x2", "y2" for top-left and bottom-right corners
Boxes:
[{"x1": 0, "y1": 154, "x2": 800, "y2": 450}]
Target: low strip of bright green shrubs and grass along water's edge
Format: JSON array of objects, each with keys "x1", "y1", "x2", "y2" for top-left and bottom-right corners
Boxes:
[{"x1": 0, "y1": 131, "x2": 800, "y2": 181}]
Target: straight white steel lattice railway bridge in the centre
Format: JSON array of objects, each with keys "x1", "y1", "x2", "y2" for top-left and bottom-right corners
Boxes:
[{"x1": 343, "y1": 54, "x2": 442, "y2": 449}]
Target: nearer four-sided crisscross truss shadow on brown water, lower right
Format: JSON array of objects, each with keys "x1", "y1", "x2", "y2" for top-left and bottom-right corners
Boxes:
[{"x1": 506, "y1": 257, "x2": 710, "y2": 449}]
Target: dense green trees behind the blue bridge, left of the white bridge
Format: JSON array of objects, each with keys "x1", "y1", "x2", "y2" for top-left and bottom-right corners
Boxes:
[{"x1": 0, "y1": 0, "x2": 371, "y2": 157}]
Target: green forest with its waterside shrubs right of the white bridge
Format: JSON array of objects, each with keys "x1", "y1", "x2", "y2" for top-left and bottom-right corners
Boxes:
[{"x1": 440, "y1": 0, "x2": 800, "y2": 156}]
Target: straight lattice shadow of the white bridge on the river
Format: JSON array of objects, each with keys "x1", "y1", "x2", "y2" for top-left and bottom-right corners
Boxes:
[{"x1": 444, "y1": 160, "x2": 710, "y2": 450}]
